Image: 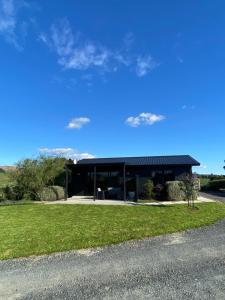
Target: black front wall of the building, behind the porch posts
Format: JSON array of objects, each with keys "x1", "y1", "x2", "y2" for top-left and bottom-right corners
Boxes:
[{"x1": 69, "y1": 165, "x2": 192, "y2": 197}]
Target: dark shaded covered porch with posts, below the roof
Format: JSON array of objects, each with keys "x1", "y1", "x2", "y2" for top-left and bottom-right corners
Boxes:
[{"x1": 66, "y1": 163, "x2": 181, "y2": 201}]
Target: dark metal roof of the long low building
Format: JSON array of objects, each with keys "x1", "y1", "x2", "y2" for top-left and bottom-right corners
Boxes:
[{"x1": 77, "y1": 155, "x2": 200, "y2": 166}]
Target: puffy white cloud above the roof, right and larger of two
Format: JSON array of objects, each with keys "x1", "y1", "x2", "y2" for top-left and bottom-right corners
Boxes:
[{"x1": 126, "y1": 112, "x2": 165, "y2": 127}]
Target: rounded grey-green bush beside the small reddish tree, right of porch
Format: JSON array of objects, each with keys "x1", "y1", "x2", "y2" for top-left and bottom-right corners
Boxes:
[{"x1": 165, "y1": 181, "x2": 186, "y2": 201}]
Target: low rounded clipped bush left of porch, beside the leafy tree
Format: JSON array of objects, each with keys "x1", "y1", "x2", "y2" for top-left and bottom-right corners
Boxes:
[{"x1": 37, "y1": 185, "x2": 65, "y2": 201}]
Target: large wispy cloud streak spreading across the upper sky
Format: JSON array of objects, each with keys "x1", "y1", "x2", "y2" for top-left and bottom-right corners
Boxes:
[{"x1": 39, "y1": 19, "x2": 159, "y2": 77}]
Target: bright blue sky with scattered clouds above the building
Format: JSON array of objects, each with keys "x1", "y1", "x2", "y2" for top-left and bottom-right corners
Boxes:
[{"x1": 0, "y1": 0, "x2": 225, "y2": 174}]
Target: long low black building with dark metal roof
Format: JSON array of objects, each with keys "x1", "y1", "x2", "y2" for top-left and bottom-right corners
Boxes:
[{"x1": 67, "y1": 155, "x2": 200, "y2": 200}]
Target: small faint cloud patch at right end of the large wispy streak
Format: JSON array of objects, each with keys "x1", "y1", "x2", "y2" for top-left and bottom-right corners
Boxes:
[{"x1": 136, "y1": 55, "x2": 159, "y2": 77}]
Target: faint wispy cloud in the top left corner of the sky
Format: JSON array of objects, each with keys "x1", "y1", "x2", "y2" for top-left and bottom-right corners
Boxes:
[{"x1": 0, "y1": 0, "x2": 28, "y2": 50}]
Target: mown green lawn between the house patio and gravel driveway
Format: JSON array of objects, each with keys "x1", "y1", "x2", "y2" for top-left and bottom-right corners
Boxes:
[{"x1": 0, "y1": 203, "x2": 225, "y2": 259}]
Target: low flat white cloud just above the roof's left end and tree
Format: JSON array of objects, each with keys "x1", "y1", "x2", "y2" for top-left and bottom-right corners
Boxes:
[{"x1": 39, "y1": 148, "x2": 94, "y2": 160}]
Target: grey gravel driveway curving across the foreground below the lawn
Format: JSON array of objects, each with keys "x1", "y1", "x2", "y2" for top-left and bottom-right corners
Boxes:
[{"x1": 0, "y1": 220, "x2": 225, "y2": 300}]
